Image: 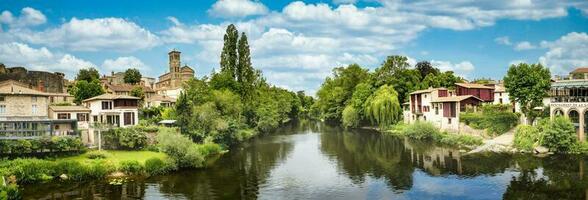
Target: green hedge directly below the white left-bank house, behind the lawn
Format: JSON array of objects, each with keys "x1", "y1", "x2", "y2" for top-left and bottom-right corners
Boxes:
[{"x1": 103, "y1": 127, "x2": 147, "y2": 149}]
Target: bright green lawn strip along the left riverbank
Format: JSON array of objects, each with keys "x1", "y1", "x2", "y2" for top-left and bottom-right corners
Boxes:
[{"x1": 63, "y1": 150, "x2": 167, "y2": 164}]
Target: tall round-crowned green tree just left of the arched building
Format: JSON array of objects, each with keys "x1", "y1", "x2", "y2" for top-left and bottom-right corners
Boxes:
[{"x1": 504, "y1": 63, "x2": 551, "y2": 122}]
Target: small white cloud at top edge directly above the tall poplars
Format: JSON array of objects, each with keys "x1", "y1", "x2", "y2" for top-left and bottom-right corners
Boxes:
[{"x1": 208, "y1": 0, "x2": 268, "y2": 18}]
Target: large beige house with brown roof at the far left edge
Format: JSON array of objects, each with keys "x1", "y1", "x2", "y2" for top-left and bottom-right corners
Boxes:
[{"x1": 0, "y1": 80, "x2": 79, "y2": 139}]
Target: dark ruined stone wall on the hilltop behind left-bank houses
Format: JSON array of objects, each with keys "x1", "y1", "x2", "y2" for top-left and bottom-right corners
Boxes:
[{"x1": 0, "y1": 63, "x2": 66, "y2": 93}]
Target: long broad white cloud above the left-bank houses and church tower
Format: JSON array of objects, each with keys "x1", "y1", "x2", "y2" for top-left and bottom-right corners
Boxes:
[{"x1": 10, "y1": 18, "x2": 159, "y2": 52}]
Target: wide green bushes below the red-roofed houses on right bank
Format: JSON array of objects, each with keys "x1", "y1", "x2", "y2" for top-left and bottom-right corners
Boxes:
[{"x1": 460, "y1": 104, "x2": 519, "y2": 134}]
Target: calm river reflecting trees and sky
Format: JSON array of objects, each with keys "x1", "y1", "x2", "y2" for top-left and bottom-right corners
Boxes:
[{"x1": 24, "y1": 122, "x2": 588, "y2": 199}]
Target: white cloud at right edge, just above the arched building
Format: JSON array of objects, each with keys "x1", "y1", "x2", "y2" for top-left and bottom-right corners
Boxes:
[{"x1": 539, "y1": 32, "x2": 588, "y2": 74}]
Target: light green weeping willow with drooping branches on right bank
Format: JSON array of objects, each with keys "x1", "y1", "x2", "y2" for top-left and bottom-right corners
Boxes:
[{"x1": 364, "y1": 85, "x2": 402, "y2": 127}]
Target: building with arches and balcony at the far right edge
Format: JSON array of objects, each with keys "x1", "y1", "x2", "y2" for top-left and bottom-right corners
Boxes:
[{"x1": 549, "y1": 67, "x2": 588, "y2": 141}]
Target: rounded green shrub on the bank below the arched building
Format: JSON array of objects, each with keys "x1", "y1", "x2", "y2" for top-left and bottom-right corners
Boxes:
[{"x1": 541, "y1": 116, "x2": 576, "y2": 152}]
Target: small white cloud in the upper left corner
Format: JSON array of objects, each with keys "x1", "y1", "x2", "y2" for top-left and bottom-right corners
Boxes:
[{"x1": 0, "y1": 7, "x2": 47, "y2": 28}]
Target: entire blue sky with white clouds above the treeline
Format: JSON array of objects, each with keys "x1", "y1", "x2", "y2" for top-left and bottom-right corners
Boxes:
[{"x1": 0, "y1": 0, "x2": 588, "y2": 94}]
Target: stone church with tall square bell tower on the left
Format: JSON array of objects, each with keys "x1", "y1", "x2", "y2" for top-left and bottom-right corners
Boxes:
[{"x1": 155, "y1": 50, "x2": 194, "y2": 98}]
